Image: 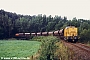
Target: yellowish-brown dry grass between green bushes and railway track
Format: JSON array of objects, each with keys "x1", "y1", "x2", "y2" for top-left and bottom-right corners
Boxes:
[{"x1": 55, "y1": 41, "x2": 74, "y2": 60}]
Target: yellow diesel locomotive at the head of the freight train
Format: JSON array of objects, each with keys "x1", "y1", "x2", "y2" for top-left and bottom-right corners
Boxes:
[{"x1": 59, "y1": 26, "x2": 79, "y2": 43}]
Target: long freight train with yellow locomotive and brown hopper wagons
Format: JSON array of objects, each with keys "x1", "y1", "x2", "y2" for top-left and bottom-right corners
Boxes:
[{"x1": 15, "y1": 26, "x2": 79, "y2": 43}]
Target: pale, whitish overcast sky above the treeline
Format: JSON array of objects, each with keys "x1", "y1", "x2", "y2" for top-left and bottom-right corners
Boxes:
[{"x1": 0, "y1": 0, "x2": 90, "y2": 19}]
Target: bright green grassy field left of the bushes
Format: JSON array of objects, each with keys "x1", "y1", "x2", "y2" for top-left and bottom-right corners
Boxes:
[{"x1": 0, "y1": 40, "x2": 41, "y2": 57}]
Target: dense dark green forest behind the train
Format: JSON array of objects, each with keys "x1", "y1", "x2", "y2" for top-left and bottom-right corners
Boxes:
[{"x1": 0, "y1": 9, "x2": 90, "y2": 41}]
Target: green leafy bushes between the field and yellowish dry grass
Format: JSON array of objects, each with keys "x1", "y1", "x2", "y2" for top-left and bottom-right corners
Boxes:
[{"x1": 34, "y1": 36, "x2": 59, "y2": 60}]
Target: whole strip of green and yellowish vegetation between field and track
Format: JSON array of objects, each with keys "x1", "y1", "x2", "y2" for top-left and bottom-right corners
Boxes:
[{"x1": 32, "y1": 36, "x2": 73, "y2": 60}]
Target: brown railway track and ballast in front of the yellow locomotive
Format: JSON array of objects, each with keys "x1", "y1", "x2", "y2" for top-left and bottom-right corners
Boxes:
[{"x1": 63, "y1": 41, "x2": 90, "y2": 60}]
